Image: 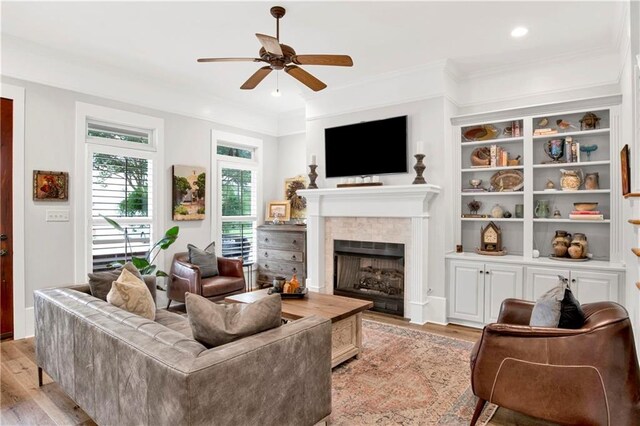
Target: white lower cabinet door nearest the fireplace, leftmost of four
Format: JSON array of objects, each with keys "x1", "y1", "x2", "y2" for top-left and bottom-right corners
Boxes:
[{"x1": 449, "y1": 261, "x2": 484, "y2": 323}]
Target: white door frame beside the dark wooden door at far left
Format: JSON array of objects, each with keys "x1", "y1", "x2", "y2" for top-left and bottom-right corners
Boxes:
[{"x1": 2, "y1": 83, "x2": 26, "y2": 340}]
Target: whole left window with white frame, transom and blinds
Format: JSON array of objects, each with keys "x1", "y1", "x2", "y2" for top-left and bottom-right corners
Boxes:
[{"x1": 74, "y1": 102, "x2": 167, "y2": 282}]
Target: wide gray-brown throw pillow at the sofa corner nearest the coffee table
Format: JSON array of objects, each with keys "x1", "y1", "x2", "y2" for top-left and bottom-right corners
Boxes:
[{"x1": 185, "y1": 293, "x2": 282, "y2": 348}]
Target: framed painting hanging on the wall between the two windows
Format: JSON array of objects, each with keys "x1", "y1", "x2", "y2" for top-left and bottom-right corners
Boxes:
[{"x1": 171, "y1": 166, "x2": 207, "y2": 221}]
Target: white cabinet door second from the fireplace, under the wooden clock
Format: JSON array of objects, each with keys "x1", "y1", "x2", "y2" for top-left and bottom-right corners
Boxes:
[{"x1": 484, "y1": 263, "x2": 523, "y2": 323}]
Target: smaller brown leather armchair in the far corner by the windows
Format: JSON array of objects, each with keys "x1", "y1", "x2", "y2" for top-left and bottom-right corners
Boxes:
[{"x1": 167, "y1": 252, "x2": 246, "y2": 309}]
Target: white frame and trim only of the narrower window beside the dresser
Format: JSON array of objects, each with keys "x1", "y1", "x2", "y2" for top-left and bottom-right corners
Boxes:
[{"x1": 209, "y1": 130, "x2": 264, "y2": 257}]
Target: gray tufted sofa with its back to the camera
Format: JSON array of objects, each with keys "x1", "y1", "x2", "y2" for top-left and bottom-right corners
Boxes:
[{"x1": 35, "y1": 286, "x2": 331, "y2": 426}]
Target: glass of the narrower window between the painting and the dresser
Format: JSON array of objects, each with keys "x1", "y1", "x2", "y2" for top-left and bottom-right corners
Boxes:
[{"x1": 216, "y1": 141, "x2": 258, "y2": 264}]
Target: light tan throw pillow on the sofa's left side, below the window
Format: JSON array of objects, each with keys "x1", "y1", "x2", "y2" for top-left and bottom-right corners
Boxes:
[{"x1": 107, "y1": 269, "x2": 156, "y2": 320}]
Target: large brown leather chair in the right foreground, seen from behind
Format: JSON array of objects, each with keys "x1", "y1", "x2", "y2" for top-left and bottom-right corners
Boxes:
[{"x1": 471, "y1": 299, "x2": 640, "y2": 426}]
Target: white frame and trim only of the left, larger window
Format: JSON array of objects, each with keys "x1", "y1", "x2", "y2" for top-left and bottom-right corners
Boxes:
[{"x1": 75, "y1": 102, "x2": 166, "y2": 282}]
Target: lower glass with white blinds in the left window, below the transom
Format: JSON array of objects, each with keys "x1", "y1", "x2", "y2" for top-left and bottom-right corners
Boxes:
[{"x1": 91, "y1": 152, "x2": 153, "y2": 271}]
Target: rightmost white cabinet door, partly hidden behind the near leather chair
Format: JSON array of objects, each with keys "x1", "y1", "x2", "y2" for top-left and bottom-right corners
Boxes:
[{"x1": 571, "y1": 271, "x2": 620, "y2": 303}]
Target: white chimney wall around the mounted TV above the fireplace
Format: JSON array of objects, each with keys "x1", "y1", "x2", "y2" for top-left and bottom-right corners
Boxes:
[{"x1": 306, "y1": 96, "x2": 451, "y2": 297}]
